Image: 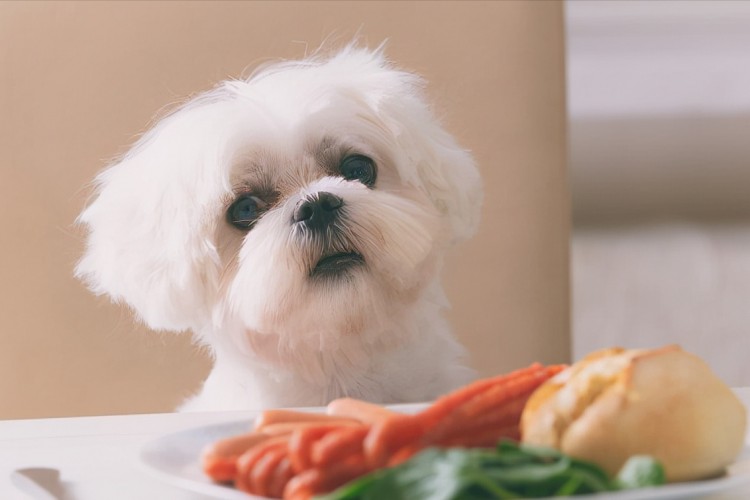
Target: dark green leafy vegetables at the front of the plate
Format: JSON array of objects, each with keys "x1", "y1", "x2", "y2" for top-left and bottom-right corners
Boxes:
[{"x1": 318, "y1": 441, "x2": 664, "y2": 500}]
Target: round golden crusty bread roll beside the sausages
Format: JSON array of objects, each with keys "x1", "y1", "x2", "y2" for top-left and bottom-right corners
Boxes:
[{"x1": 521, "y1": 346, "x2": 746, "y2": 481}]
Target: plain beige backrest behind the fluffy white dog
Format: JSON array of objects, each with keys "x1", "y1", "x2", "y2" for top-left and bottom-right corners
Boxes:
[{"x1": 0, "y1": 1, "x2": 569, "y2": 418}]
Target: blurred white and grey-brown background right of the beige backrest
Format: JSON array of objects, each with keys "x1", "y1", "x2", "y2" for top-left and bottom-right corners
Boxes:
[{"x1": 566, "y1": 0, "x2": 750, "y2": 386}]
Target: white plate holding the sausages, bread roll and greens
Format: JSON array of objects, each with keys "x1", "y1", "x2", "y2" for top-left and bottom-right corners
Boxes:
[{"x1": 140, "y1": 405, "x2": 750, "y2": 500}]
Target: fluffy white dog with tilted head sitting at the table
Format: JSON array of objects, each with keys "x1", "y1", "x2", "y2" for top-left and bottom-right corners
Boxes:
[{"x1": 76, "y1": 46, "x2": 481, "y2": 410}]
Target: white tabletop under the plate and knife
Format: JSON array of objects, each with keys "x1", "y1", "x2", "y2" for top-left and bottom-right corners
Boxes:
[{"x1": 0, "y1": 388, "x2": 750, "y2": 500}]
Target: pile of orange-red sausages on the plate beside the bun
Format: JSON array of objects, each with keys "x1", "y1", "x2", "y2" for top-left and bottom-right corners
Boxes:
[{"x1": 203, "y1": 363, "x2": 564, "y2": 500}]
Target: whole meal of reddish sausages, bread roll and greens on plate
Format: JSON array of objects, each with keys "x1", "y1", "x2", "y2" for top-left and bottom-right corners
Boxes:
[{"x1": 203, "y1": 346, "x2": 746, "y2": 500}]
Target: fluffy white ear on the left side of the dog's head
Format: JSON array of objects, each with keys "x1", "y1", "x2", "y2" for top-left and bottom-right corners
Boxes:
[{"x1": 75, "y1": 96, "x2": 231, "y2": 331}]
